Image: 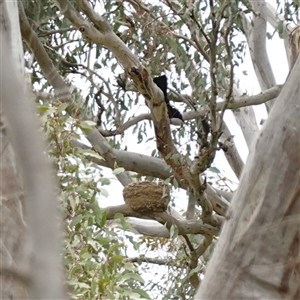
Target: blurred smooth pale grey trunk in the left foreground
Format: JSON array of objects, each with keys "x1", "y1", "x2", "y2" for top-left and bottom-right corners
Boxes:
[{"x1": 0, "y1": 1, "x2": 68, "y2": 299}]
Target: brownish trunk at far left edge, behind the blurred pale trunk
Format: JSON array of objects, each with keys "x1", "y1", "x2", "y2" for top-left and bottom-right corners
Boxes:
[{"x1": 0, "y1": 119, "x2": 29, "y2": 299}]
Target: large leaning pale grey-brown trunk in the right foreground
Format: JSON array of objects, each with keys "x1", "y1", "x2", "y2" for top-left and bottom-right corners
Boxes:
[{"x1": 195, "y1": 57, "x2": 300, "y2": 300}]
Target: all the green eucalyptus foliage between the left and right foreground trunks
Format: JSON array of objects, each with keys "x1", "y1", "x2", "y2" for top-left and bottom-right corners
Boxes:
[{"x1": 19, "y1": 0, "x2": 299, "y2": 299}]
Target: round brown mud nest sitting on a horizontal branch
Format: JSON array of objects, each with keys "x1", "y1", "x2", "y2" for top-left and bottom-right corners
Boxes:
[{"x1": 123, "y1": 181, "x2": 170, "y2": 213}]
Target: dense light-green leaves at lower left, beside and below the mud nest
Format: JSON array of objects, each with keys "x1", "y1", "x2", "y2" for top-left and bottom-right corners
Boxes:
[{"x1": 38, "y1": 104, "x2": 199, "y2": 299}]
